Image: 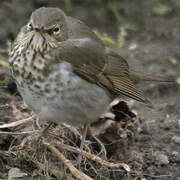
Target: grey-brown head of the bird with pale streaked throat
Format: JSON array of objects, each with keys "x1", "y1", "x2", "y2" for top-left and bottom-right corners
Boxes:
[{"x1": 19, "y1": 8, "x2": 66, "y2": 51}]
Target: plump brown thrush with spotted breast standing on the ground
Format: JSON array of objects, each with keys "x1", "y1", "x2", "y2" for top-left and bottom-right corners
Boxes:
[{"x1": 9, "y1": 7, "x2": 173, "y2": 165}]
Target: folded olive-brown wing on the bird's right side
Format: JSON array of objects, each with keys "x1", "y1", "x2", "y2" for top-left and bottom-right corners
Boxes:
[{"x1": 55, "y1": 38, "x2": 150, "y2": 106}]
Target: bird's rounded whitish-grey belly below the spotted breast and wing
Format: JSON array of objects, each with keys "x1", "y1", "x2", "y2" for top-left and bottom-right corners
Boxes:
[{"x1": 16, "y1": 62, "x2": 111, "y2": 125}]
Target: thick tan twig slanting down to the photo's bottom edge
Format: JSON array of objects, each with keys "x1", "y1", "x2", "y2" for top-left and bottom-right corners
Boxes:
[{"x1": 43, "y1": 141, "x2": 93, "y2": 180}]
